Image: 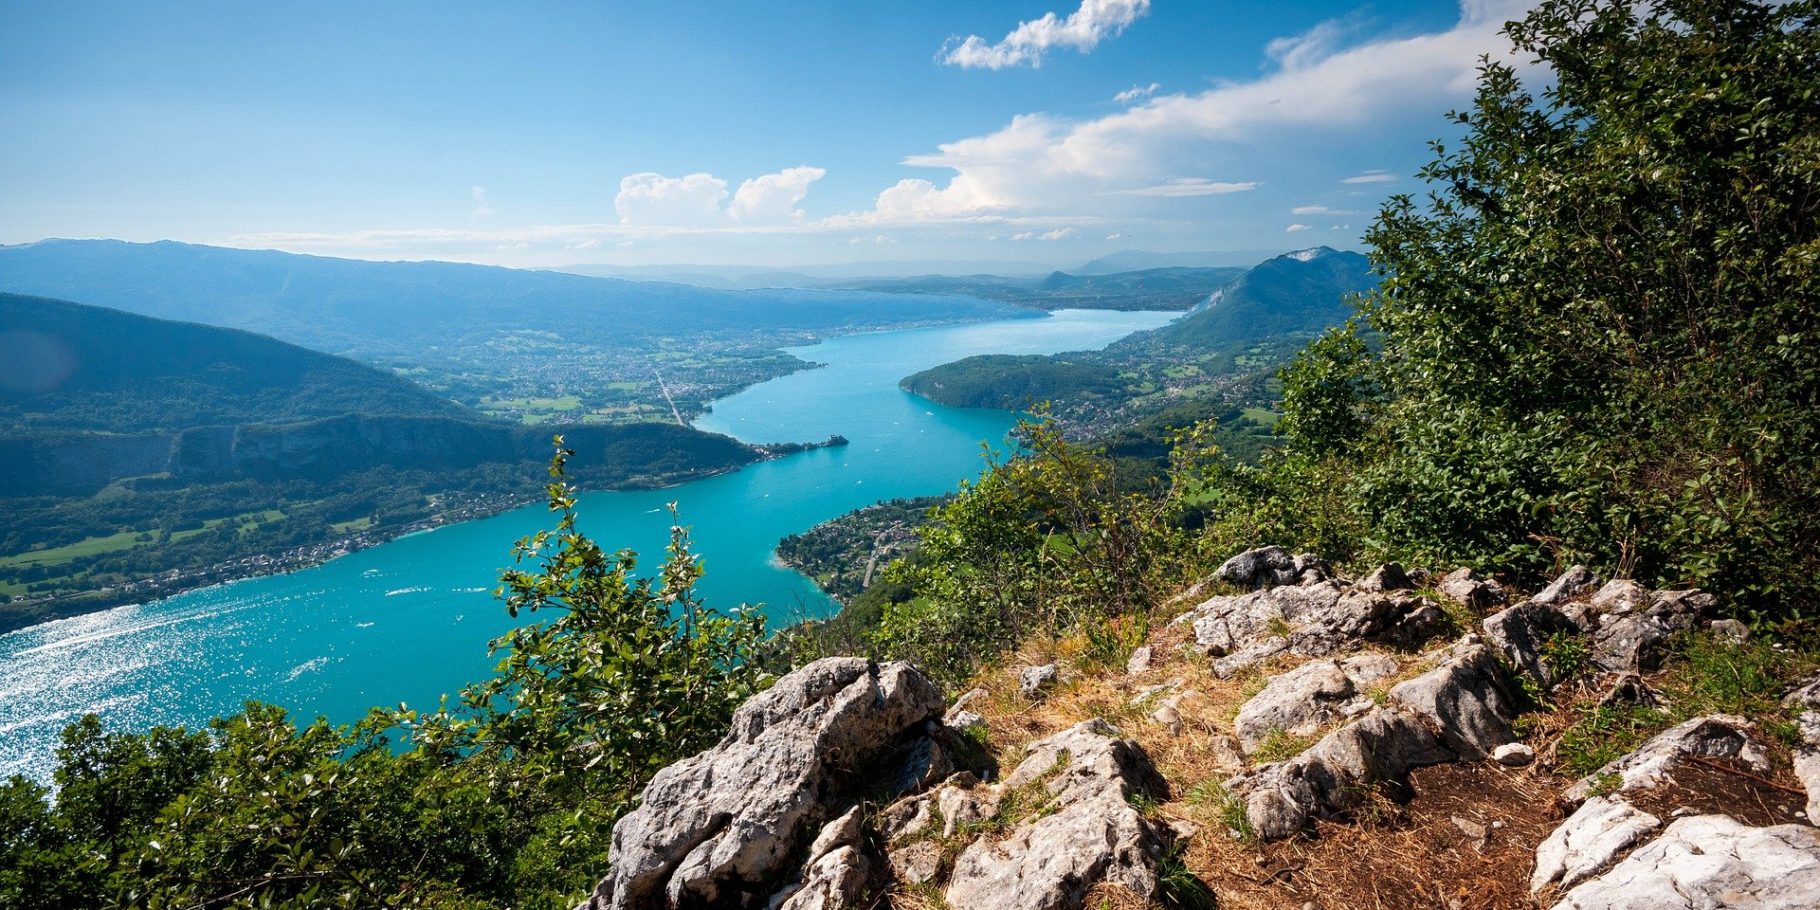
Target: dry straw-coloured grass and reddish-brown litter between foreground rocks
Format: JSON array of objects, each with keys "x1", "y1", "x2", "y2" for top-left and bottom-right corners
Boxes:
[{"x1": 946, "y1": 604, "x2": 1562, "y2": 910}]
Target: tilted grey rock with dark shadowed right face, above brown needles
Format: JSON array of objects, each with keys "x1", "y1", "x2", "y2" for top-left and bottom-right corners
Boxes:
[{"x1": 1390, "y1": 641, "x2": 1516, "y2": 761}]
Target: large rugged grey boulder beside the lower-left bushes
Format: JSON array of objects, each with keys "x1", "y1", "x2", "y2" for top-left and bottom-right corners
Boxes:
[{"x1": 584, "y1": 657, "x2": 941, "y2": 910}]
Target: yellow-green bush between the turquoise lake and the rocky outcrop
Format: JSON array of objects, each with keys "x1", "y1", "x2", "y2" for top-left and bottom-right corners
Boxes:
[{"x1": 874, "y1": 420, "x2": 1214, "y2": 683}]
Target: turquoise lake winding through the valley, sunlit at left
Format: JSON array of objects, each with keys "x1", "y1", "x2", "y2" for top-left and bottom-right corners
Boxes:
[{"x1": 0, "y1": 309, "x2": 1174, "y2": 779}]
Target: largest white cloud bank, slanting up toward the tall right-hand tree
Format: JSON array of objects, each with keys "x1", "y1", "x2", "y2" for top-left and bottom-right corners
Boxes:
[{"x1": 854, "y1": 0, "x2": 1531, "y2": 220}]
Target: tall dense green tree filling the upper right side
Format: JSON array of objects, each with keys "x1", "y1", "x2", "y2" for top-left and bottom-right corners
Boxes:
[{"x1": 1229, "y1": 0, "x2": 1820, "y2": 619}]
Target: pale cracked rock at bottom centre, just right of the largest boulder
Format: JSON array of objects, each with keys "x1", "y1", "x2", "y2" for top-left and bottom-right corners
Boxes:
[{"x1": 946, "y1": 721, "x2": 1172, "y2": 910}]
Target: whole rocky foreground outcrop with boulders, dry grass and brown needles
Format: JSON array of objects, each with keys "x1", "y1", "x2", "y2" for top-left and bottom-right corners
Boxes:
[{"x1": 584, "y1": 548, "x2": 1820, "y2": 910}]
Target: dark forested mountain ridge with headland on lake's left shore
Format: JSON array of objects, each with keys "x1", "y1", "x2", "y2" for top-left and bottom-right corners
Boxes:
[{"x1": 0, "y1": 295, "x2": 763, "y2": 630}]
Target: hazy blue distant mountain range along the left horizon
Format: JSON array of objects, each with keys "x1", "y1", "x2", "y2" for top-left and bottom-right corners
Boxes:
[{"x1": 0, "y1": 240, "x2": 1014, "y2": 360}]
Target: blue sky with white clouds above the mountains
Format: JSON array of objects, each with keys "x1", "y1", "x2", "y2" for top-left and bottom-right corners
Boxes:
[{"x1": 0, "y1": 0, "x2": 1522, "y2": 266}]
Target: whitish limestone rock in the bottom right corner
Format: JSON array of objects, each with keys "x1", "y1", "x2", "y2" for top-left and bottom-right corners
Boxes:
[{"x1": 1554, "y1": 815, "x2": 1820, "y2": 910}]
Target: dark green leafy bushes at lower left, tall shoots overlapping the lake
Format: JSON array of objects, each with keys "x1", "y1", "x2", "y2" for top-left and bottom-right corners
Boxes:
[{"x1": 0, "y1": 439, "x2": 764, "y2": 908}]
